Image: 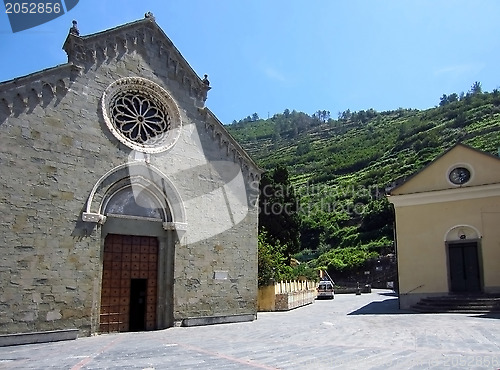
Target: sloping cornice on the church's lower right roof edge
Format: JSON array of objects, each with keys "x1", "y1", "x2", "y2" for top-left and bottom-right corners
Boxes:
[{"x1": 199, "y1": 108, "x2": 264, "y2": 181}]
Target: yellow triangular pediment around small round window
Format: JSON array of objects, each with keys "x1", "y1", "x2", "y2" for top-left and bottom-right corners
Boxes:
[{"x1": 390, "y1": 143, "x2": 500, "y2": 195}]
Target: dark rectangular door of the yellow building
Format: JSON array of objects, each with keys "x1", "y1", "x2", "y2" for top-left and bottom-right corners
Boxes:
[{"x1": 448, "y1": 243, "x2": 481, "y2": 293}]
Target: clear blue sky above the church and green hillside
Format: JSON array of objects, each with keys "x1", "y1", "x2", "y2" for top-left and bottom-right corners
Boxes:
[{"x1": 0, "y1": 0, "x2": 500, "y2": 123}]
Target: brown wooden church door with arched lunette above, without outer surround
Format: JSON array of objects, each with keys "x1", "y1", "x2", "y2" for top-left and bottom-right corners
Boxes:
[{"x1": 99, "y1": 184, "x2": 167, "y2": 333}]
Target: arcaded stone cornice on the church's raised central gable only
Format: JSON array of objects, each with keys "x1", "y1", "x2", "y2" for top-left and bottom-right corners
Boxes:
[{"x1": 63, "y1": 17, "x2": 210, "y2": 103}]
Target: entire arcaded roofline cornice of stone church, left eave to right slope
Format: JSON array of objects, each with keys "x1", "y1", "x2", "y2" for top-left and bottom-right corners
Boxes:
[{"x1": 0, "y1": 13, "x2": 263, "y2": 178}]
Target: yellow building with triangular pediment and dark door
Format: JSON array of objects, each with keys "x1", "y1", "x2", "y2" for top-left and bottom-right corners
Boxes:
[{"x1": 389, "y1": 144, "x2": 500, "y2": 308}]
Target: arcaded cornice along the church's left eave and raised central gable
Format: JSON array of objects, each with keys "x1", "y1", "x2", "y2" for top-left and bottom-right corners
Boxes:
[{"x1": 0, "y1": 13, "x2": 210, "y2": 112}]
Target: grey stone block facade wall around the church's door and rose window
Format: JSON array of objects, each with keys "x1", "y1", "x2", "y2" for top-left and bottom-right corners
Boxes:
[{"x1": 0, "y1": 18, "x2": 258, "y2": 335}]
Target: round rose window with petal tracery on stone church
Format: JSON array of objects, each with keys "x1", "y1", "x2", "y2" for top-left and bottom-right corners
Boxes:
[{"x1": 102, "y1": 77, "x2": 181, "y2": 153}]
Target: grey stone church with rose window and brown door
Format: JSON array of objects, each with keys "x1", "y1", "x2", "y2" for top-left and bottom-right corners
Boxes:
[{"x1": 0, "y1": 13, "x2": 262, "y2": 335}]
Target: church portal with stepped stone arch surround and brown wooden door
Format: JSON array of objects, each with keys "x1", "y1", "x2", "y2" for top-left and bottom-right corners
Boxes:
[{"x1": 82, "y1": 162, "x2": 186, "y2": 332}]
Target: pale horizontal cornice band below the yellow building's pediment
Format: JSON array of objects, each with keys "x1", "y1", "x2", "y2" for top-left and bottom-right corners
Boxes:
[{"x1": 388, "y1": 184, "x2": 500, "y2": 208}]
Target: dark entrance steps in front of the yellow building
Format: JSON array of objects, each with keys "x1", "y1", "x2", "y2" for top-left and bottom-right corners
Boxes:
[{"x1": 412, "y1": 294, "x2": 500, "y2": 314}]
